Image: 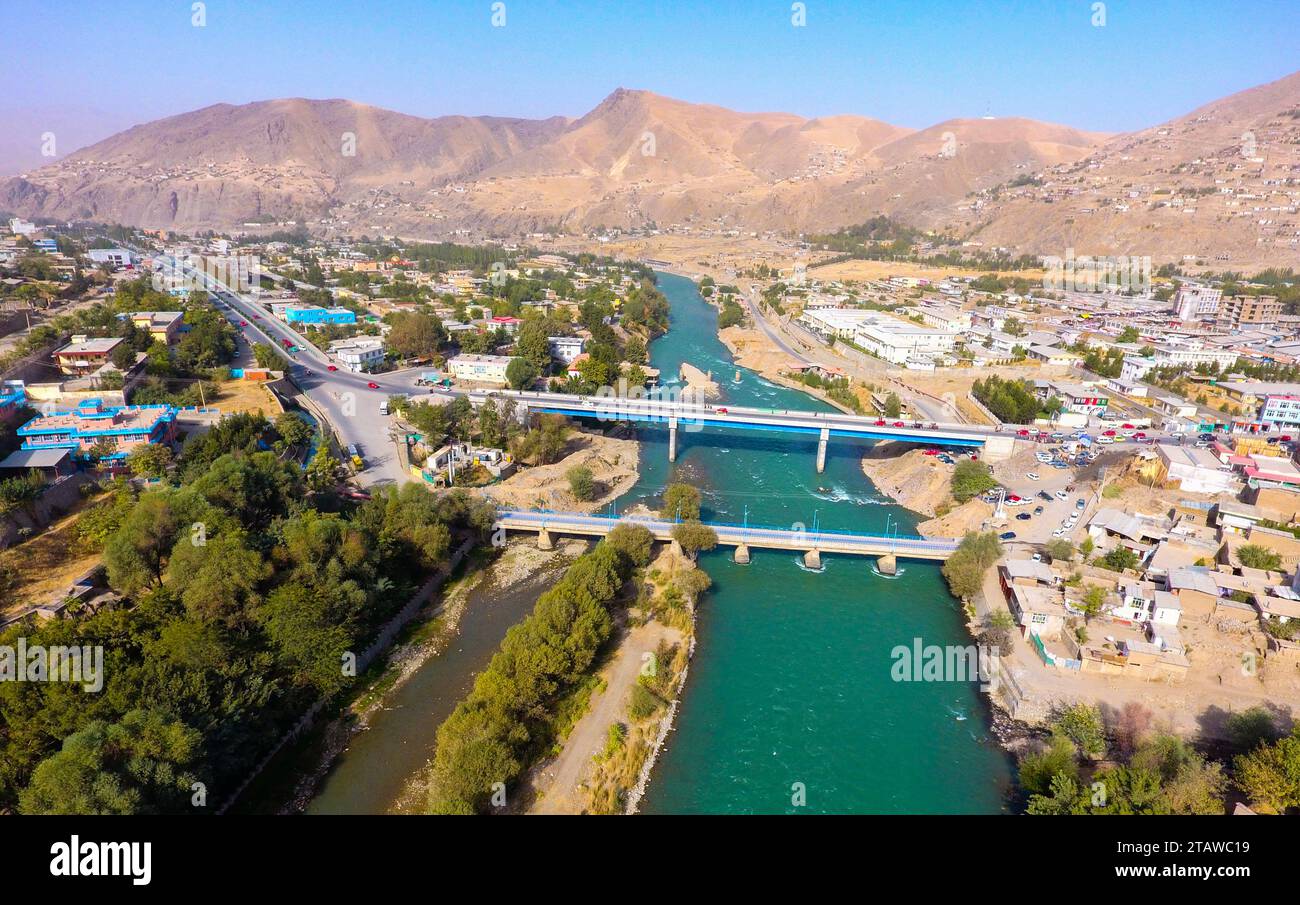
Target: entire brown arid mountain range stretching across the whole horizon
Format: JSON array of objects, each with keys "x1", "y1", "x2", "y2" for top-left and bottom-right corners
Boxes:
[{"x1": 0, "y1": 74, "x2": 1300, "y2": 265}]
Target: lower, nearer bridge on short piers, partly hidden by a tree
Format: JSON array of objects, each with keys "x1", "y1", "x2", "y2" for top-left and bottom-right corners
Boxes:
[{"x1": 493, "y1": 510, "x2": 957, "y2": 575}]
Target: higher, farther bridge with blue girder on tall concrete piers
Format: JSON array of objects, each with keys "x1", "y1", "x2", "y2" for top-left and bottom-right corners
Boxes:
[{"x1": 449, "y1": 390, "x2": 1015, "y2": 472}]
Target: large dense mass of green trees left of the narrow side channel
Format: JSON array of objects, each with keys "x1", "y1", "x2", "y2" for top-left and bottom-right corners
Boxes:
[{"x1": 0, "y1": 415, "x2": 491, "y2": 813}]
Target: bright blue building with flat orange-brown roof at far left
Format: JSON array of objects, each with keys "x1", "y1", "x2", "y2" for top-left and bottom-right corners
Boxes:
[{"x1": 18, "y1": 399, "x2": 177, "y2": 460}]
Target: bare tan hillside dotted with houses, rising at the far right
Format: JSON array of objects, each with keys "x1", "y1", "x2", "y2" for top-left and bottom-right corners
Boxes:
[{"x1": 950, "y1": 73, "x2": 1300, "y2": 269}]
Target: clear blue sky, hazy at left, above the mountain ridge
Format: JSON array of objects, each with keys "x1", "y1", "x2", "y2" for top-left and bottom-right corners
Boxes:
[{"x1": 0, "y1": 0, "x2": 1300, "y2": 131}]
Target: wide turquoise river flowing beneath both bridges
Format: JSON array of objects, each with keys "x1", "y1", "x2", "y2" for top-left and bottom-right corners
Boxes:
[{"x1": 619, "y1": 273, "x2": 1013, "y2": 814}]
